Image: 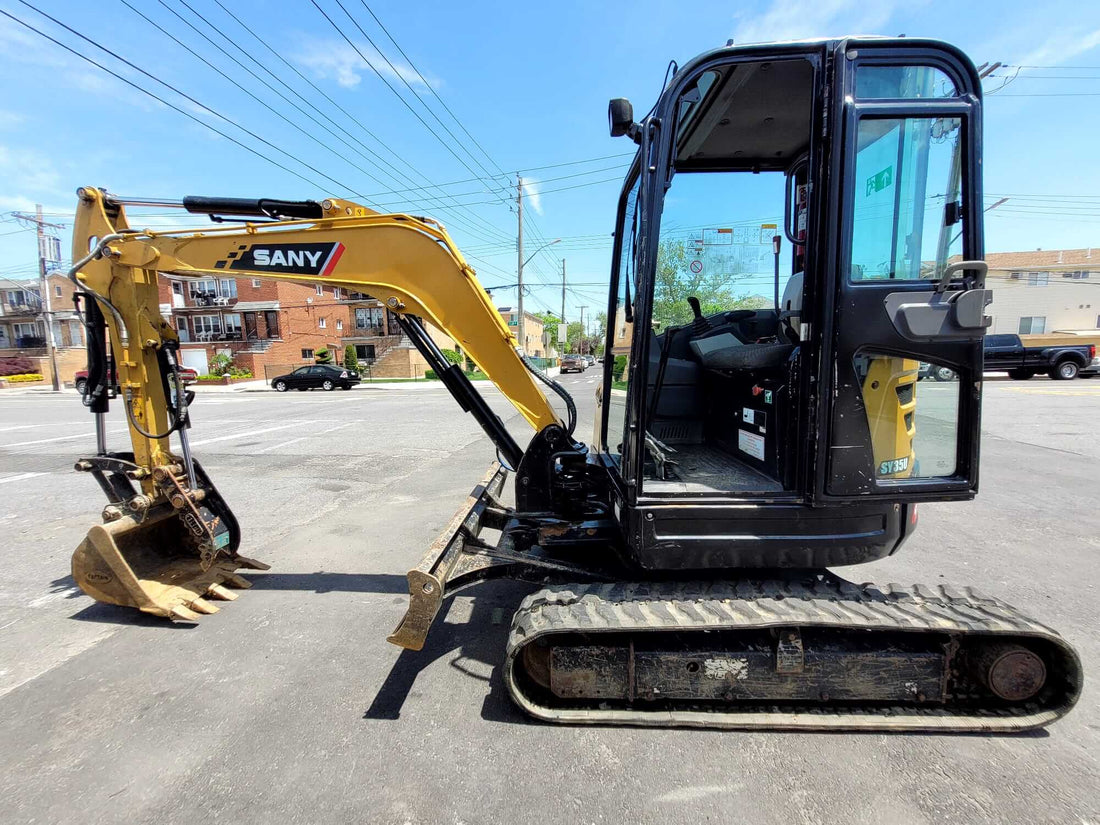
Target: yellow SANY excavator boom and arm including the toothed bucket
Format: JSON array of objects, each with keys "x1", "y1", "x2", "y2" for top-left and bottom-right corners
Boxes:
[{"x1": 70, "y1": 187, "x2": 574, "y2": 633}]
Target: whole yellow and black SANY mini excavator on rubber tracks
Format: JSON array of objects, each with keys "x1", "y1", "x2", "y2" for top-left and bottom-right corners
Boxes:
[{"x1": 72, "y1": 37, "x2": 1082, "y2": 732}]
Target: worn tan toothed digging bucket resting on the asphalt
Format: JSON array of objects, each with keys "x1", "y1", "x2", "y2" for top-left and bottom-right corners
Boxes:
[{"x1": 73, "y1": 506, "x2": 270, "y2": 622}]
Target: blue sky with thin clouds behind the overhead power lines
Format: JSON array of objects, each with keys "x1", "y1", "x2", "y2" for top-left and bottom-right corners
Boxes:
[{"x1": 0, "y1": 0, "x2": 1100, "y2": 318}]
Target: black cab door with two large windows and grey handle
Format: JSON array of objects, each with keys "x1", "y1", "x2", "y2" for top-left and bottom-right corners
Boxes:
[{"x1": 818, "y1": 53, "x2": 991, "y2": 502}]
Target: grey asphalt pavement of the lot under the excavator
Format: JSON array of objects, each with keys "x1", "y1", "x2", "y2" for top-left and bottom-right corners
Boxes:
[{"x1": 0, "y1": 370, "x2": 1100, "y2": 825}]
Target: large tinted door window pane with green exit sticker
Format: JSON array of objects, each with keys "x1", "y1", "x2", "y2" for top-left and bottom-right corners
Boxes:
[{"x1": 848, "y1": 118, "x2": 963, "y2": 281}]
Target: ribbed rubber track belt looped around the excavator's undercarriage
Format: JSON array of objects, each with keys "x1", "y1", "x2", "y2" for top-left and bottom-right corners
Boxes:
[{"x1": 504, "y1": 580, "x2": 1082, "y2": 733}]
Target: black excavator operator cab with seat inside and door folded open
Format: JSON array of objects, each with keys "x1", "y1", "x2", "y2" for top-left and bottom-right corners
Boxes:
[{"x1": 594, "y1": 40, "x2": 991, "y2": 570}]
